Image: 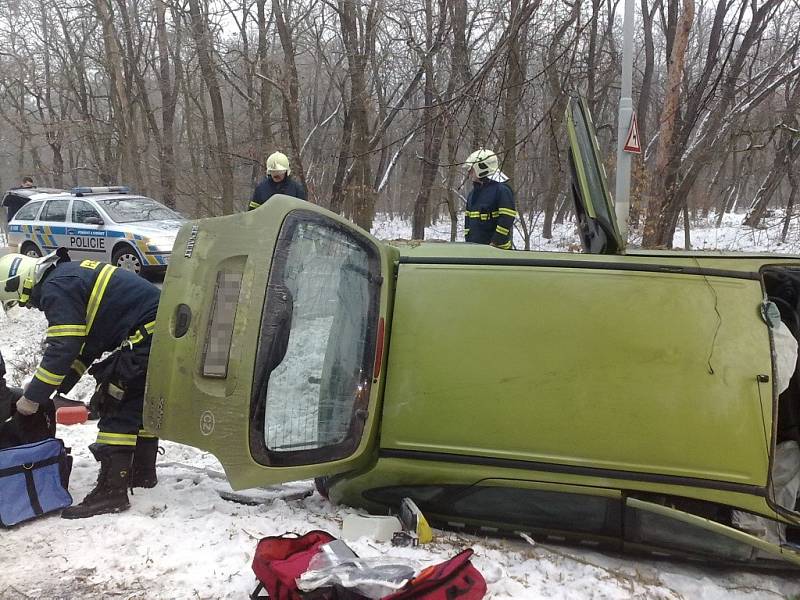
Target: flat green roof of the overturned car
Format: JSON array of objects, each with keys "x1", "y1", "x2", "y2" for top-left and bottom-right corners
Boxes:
[{"x1": 381, "y1": 264, "x2": 772, "y2": 486}]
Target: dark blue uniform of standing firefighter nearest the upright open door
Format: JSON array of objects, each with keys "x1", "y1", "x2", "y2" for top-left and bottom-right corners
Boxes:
[{"x1": 464, "y1": 178, "x2": 517, "y2": 249}]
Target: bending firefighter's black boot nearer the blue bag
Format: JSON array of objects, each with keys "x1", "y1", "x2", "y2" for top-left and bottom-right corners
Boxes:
[{"x1": 61, "y1": 444, "x2": 133, "y2": 519}]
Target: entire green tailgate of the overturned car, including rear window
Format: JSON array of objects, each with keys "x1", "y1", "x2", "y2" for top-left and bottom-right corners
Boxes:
[{"x1": 145, "y1": 196, "x2": 390, "y2": 488}]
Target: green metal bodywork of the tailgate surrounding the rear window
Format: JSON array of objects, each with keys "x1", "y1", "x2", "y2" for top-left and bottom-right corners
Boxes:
[{"x1": 144, "y1": 196, "x2": 394, "y2": 488}]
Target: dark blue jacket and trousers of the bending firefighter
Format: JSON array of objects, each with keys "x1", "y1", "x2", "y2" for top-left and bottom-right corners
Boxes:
[{"x1": 25, "y1": 260, "x2": 160, "y2": 446}]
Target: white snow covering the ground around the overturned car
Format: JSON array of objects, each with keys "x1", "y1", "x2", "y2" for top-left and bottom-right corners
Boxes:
[{"x1": 0, "y1": 216, "x2": 800, "y2": 600}]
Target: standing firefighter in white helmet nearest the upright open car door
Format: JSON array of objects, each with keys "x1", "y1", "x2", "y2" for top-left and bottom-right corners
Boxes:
[{"x1": 464, "y1": 148, "x2": 517, "y2": 250}]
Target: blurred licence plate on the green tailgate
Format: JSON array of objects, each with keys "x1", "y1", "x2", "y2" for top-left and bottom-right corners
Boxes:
[{"x1": 203, "y1": 271, "x2": 242, "y2": 377}]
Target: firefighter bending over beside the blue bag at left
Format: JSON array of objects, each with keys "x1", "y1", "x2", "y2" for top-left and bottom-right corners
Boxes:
[{"x1": 0, "y1": 250, "x2": 159, "y2": 519}]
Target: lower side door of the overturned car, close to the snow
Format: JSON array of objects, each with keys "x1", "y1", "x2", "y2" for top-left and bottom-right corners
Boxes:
[{"x1": 622, "y1": 497, "x2": 800, "y2": 568}]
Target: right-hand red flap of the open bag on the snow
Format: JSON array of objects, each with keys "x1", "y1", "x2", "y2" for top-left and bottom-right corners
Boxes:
[{"x1": 382, "y1": 548, "x2": 486, "y2": 600}]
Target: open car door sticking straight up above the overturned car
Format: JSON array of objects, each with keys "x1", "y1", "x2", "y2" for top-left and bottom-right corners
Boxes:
[{"x1": 564, "y1": 97, "x2": 625, "y2": 254}]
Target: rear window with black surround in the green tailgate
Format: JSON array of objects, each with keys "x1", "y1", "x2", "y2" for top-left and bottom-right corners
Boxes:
[{"x1": 251, "y1": 211, "x2": 380, "y2": 466}]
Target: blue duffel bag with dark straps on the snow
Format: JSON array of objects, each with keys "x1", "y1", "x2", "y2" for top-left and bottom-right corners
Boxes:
[{"x1": 0, "y1": 438, "x2": 72, "y2": 527}]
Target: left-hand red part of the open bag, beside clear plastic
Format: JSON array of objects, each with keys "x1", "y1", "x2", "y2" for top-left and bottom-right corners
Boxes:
[{"x1": 250, "y1": 531, "x2": 336, "y2": 600}]
